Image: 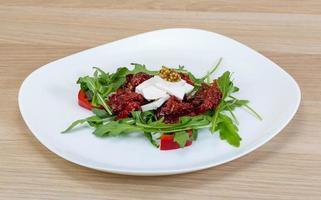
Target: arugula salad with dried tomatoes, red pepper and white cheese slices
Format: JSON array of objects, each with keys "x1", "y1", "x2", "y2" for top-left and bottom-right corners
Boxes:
[{"x1": 63, "y1": 59, "x2": 261, "y2": 150}]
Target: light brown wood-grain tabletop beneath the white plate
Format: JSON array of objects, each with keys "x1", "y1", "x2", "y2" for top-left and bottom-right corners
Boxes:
[{"x1": 0, "y1": 0, "x2": 321, "y2": 200}]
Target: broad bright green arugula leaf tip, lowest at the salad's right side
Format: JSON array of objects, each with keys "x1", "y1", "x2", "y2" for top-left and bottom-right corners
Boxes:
[{"x1": 217, "y1": 114, "x2": 242, "y2": 147}]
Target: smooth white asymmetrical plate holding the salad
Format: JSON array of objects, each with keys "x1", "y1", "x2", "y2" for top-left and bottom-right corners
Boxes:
[{"x1": 19, "y1": 29, "x2": 301, "y2": 175}]
